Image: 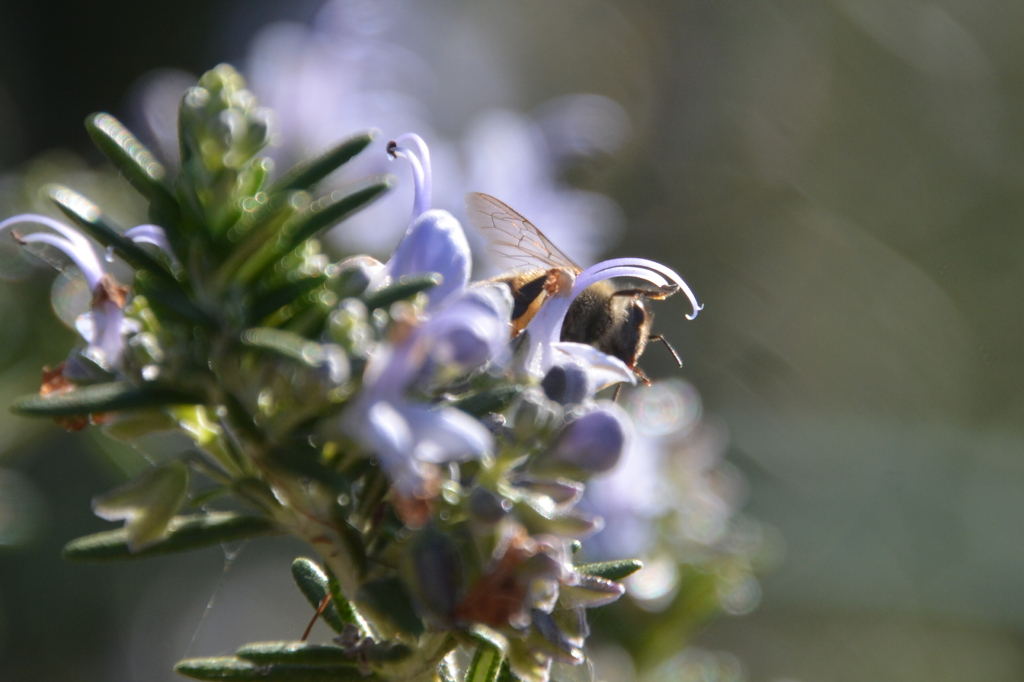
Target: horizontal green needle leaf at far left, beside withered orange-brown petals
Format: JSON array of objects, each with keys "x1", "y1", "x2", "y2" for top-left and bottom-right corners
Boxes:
[{"x1": 11, "y1": 382, "x2": 205, "y2": 417}]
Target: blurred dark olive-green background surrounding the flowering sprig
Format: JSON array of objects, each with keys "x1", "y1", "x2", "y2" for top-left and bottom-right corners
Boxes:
[{"x1": 0, "y1": 0, "x2": 1024, "y2": 682}]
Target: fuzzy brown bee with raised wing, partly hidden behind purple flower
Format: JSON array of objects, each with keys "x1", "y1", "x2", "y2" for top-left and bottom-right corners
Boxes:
[{"x1": 466, "y1": 191, "x2": 683, "y2": 384}]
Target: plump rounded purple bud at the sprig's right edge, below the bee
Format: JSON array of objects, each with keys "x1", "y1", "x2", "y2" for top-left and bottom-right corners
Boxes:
[{"x1": 548, "y1": 402, "x2": 630, "y2": 473}]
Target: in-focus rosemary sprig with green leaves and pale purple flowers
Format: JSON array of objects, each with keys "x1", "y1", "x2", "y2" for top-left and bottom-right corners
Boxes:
[{"x1": 0, "y1": 66, "x2": 697, "y2": 682}]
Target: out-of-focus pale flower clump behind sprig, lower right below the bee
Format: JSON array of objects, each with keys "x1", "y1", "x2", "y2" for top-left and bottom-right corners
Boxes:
[{"x1": 582, "y1": 379, "x2": 781, "y2": 680}]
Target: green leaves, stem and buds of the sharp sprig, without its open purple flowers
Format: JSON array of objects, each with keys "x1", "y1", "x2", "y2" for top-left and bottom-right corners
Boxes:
[{"x1": 14, "y1": 66, "x2": 639, "y2": 681}]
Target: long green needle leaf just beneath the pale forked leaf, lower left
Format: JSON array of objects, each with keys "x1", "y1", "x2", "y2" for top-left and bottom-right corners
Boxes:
[{"x1": 61, "y1": 512, "x2": 278, "y2": 561}]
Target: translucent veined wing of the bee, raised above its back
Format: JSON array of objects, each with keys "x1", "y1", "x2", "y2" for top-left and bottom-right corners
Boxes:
[{"x1": 466, "y1": 191, "x2": 582, "y2": 273}]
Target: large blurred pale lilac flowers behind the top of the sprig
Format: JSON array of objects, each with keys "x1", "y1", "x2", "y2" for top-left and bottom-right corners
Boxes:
[{"x1": 128, "y1": 0, "x2": 630, "y2": 267}]
